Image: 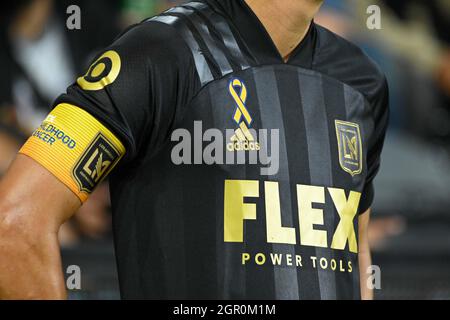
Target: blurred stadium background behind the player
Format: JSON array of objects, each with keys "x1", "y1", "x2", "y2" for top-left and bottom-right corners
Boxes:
[{"x1": 0, "y1": 0, "x2": 450, "y2": 299}]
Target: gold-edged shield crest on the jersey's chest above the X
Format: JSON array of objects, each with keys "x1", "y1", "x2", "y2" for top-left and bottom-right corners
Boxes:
[{"x1": 335, "y1": 120, "x2": 363, "y2": 176}]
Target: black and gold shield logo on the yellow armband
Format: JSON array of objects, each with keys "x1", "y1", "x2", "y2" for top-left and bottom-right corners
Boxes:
[{"x1": 73, "y1": 133, "x2": 120, "y2": 193}]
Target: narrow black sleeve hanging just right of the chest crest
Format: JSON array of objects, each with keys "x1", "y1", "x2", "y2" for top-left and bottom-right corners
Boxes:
[{"x1": 359, "y1": 78, "x2": 389, "y2": 213}]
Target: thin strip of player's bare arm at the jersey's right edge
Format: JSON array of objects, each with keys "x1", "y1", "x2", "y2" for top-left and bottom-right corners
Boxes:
[{"x1": 358, "y1": 209, "x2": 373, "y2": 300}]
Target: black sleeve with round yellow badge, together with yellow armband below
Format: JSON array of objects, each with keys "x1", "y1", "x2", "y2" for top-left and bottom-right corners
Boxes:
[{"x1": 20, "y1": 22, "x2": 199, "y2": 202}]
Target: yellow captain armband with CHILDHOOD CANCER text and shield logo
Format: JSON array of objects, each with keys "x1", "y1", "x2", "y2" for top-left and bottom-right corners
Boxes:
[{"x1": 19, "y1": 104, "x2": 125, "y2": 202}]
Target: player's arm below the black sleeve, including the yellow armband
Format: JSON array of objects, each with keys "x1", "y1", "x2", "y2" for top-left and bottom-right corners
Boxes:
[{"x1": 0, "y1": 104, "x2": 125, "y2": 299}]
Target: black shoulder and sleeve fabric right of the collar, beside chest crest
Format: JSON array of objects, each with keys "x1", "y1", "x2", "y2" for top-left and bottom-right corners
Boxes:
[{"x1": 313, "y1": 26, "x2": 389, "y2": 213}]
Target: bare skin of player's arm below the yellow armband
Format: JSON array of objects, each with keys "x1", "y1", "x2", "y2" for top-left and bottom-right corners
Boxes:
[{"x1": 0, "y1": 155, "x2": 81, "y2": 299}]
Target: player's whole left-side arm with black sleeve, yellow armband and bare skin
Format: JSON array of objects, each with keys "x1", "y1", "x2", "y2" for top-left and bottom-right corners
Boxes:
[{"x1": 0, "y1": 22, "x2": 193, "y2": 299}]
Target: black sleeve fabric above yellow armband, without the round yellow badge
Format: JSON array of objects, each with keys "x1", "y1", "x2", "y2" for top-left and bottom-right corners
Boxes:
[{"x1": 55, "y1": 22, "x2": 198, "y2": 159}]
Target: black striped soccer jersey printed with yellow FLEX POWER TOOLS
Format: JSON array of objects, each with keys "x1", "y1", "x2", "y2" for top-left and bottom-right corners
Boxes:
[{"x1": 22, "y1": 0, "x2": 388, "y2": 299}]
